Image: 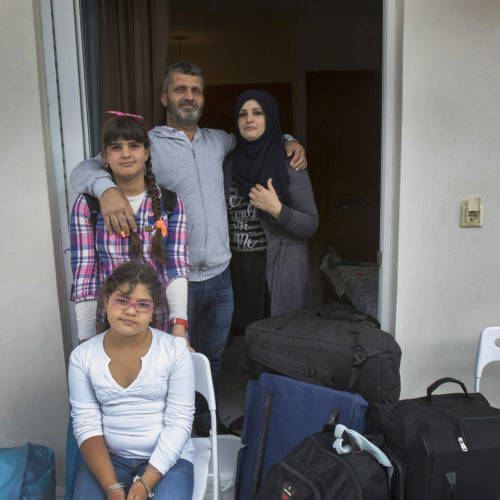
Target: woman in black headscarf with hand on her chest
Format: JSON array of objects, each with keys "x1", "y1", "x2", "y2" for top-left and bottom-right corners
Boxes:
[{"x1": 224, "y1": 90, "x2": 318, "y2": 329}]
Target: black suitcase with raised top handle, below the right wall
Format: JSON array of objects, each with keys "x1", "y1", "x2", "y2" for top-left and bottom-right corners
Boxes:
[{"x1": 367, "y1": 378, "x2": 500, "y2": 500}]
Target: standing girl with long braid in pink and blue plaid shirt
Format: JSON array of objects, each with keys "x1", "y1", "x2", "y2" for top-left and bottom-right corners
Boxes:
[{"x1": 70, "y1": 111, "x2": 189, "y2": 346}]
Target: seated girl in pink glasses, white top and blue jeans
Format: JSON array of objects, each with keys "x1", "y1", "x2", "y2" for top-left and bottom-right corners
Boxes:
[{"x1": 68, "y1": 262, "x2": 194, "y2": 500}]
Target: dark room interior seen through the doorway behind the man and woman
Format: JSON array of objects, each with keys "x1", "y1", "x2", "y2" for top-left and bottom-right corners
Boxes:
[{"x1": 168, "y1": 0, "x2": 383, "y2": 304}]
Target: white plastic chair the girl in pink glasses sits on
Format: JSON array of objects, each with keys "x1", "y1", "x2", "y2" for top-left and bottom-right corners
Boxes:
[{"x1": 191, "y1": 352, "x2": 220, "y2": 500}]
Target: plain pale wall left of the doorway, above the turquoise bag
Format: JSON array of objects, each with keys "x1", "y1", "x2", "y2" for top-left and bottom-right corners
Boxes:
[{"x1": 0, "y1": 0, "x2": 68, "y2": 482}]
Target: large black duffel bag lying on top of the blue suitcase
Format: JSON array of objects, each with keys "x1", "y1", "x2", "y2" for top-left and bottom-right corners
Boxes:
[{"x1": 245, "y1": 302, "x2": 401, "y2": 401}]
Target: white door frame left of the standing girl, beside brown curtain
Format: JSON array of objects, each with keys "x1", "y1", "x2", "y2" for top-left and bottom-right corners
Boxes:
[{"x1": 41, "y1": 0, "x2": 90, "y2": 356}]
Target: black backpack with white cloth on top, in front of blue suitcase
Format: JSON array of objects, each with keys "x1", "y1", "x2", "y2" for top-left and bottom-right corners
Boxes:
[{"x1": 256, "y1": 414, "x2": 392, "y2": 500}]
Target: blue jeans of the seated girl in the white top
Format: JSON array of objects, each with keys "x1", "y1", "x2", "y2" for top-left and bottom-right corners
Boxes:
[{"x1": 73, "y1": 453, "x2": 194, "y2": 500}]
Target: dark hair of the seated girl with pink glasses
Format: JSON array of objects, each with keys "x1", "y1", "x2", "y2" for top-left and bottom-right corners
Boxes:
[{"x1": 99, "y1": 260, "x2": 165, "y2": 329}]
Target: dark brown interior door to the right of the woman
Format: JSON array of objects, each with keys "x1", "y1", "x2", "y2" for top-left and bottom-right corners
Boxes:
[{"x1": 306, "y1": 71, "x2": 381, "y2": 263}]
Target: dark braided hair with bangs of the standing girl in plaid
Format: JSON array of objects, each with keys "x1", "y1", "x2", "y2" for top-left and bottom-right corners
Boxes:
[{"x1": 101, "y1": 116, "x2": 167, "y2": 262}]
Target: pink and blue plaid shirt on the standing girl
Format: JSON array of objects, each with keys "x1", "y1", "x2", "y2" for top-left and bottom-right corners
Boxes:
[{"x1": 70, "y1": 189, "x2": 189, "y2": 331}]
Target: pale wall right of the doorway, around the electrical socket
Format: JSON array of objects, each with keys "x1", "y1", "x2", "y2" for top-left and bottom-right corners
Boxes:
[{"x1": 396, "y1": 0, "x2": 500, "y2": 405}]
